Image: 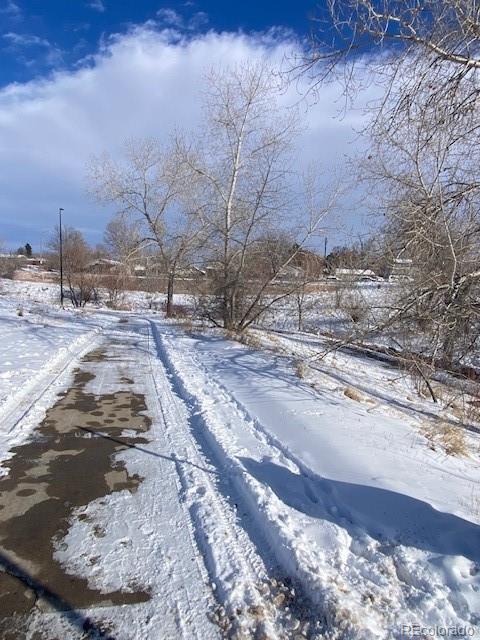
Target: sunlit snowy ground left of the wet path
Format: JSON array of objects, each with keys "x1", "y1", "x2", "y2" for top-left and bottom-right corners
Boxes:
[{"x1": 0, "y1": 283, "x2": 118, "y2": 468}]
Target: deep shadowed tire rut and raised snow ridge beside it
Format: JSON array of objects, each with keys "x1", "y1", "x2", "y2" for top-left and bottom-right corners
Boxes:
[{"x1": 148, "y1": 320, "x2": 326, "y2": 638}]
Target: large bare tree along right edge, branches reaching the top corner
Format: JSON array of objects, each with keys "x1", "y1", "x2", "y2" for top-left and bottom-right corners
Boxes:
[{"x1": 298, "y1": 0, "x2": 480, "y2": 398}]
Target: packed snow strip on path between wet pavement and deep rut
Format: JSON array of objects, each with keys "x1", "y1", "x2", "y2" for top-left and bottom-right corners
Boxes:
[{"x1": 48, "y1": 316, "x2": 318, "y2": 640}]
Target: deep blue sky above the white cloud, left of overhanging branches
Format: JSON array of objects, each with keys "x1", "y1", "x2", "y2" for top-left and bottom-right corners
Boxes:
[{"x1": 0, "y1": 0, "x2": 318, "y2": 85}]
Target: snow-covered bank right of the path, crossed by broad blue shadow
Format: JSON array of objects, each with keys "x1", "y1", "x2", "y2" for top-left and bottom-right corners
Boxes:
[{"x1": 157, "y1": 325, "x2": 480, "y2": 638}]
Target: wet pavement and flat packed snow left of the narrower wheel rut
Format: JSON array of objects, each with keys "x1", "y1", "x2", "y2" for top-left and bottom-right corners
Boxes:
[{"x1": 0, "y1": 321, "x2": 218, "y2": 639}]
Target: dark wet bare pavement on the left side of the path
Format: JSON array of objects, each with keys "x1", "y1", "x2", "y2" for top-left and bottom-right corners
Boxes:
[{"x1": 0, "y1": 342, "x2": 150, "y2": 637}]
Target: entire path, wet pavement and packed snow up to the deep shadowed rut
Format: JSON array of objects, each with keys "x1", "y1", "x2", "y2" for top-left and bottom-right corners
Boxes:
[{"x1": 0, "y1": 316, "x2": 315, "y2": 640}]
